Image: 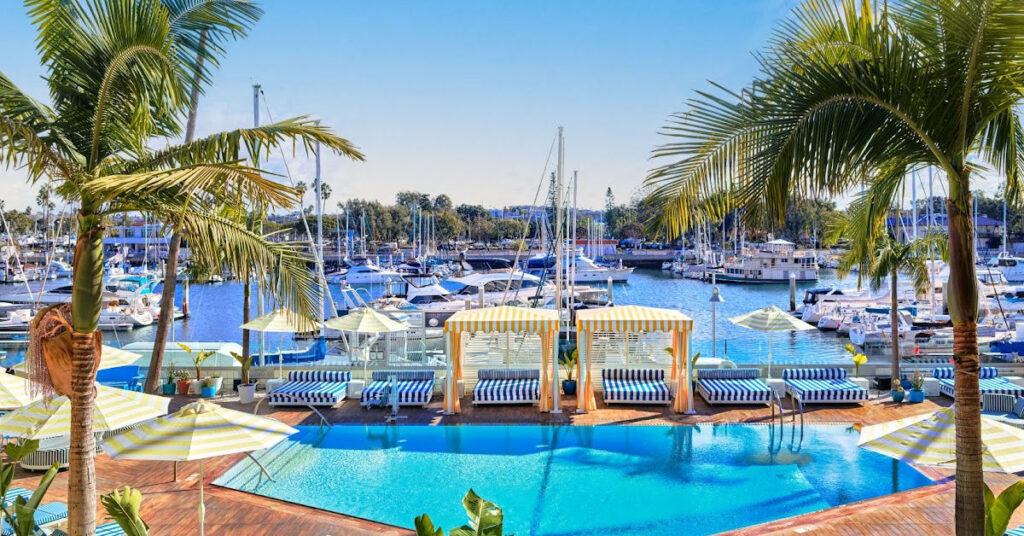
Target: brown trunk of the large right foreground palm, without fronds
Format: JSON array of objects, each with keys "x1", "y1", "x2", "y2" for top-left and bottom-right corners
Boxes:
[{"x1": 946, "y1": 170, "x2": 985, "y2": 536}]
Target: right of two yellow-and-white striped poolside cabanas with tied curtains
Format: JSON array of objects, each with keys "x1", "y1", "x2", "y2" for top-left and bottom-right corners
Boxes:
[{"x1": 575, "y1": 305, "x2": 693, "y2": 413}]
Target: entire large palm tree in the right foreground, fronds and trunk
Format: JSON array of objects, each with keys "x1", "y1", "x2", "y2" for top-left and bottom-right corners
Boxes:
[{"x1": 648, "y1": 0, "x2": 1024, "y2": 536}]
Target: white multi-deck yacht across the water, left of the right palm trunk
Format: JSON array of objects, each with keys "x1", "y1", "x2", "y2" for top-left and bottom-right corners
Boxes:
[{"x1": 717, "y1": 240, "x2": 818, "y2": 284}]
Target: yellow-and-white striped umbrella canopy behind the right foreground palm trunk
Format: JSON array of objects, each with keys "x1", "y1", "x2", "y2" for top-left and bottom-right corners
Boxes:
[{"x1": 859, "y1": 408, "x2": 1024, "y2": 472}]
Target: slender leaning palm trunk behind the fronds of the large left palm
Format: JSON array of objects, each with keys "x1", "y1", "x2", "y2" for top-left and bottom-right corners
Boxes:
[{"x1": 144, "y1": 30, "x2": 207, "y2": 393}]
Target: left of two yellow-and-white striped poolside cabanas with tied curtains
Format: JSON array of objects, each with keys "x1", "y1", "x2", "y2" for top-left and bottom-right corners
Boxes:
[{"x1": 444, "y1": 305, "x2": 558, "y2": 413}]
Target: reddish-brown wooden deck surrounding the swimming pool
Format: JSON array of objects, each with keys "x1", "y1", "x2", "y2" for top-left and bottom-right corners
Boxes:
[{"x1": 14, "y1": 397, "x2": 1024, "y2": 536}]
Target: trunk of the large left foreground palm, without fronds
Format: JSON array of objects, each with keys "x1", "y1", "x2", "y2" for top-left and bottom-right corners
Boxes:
[{"x1": 68, "y1": 210, "x2": 103, "y2": 536}]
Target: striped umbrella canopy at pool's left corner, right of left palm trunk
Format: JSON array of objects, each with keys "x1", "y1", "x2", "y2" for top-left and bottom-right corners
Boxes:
[{"x1": 100, "y1": 400, "x2": 298, "y2": 461}]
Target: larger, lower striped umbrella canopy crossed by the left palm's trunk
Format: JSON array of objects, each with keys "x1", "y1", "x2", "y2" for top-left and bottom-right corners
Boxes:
[{"x1": 0, "y1": 383, "x2": 170, "y2": 440}]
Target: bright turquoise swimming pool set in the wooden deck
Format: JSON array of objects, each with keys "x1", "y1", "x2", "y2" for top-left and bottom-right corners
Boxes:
[{"x1": 214, "y1": 424, "x2": 931, "y2": 536}]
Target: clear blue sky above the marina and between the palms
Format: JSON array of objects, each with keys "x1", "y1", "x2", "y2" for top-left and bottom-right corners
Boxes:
[{"x1": 0, "y1": 0, "x2": 999, "y2": 216}]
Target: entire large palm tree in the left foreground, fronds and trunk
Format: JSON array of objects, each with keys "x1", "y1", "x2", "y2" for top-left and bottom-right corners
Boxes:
[{"x1": 0, "y1": 0, "x2": 361, "y2": 536}]
